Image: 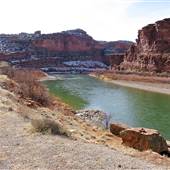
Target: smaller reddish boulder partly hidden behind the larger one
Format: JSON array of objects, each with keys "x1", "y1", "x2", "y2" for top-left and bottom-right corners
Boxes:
[{"x1": 110, "y1": 123, "x2": 129, "y2": 136}]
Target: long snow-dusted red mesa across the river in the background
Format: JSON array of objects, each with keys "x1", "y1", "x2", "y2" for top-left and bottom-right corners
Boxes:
[{"x1": 0, "y1": 29, "x2": 132, "y2": 68}]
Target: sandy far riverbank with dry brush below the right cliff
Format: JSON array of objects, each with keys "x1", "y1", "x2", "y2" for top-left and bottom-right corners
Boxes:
[{"x1": 89, "y1": 73, "x2": 170, "y2": 95}]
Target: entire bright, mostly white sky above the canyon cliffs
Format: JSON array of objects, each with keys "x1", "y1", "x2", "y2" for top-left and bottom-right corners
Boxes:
[{"x1": 0, "y1": 0, "x2": 170, "y2": 41}]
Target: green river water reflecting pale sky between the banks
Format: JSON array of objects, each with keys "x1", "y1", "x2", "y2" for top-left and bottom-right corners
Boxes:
[{"x1": 44, "y1": 75, "x2": 170, "y2": 139}]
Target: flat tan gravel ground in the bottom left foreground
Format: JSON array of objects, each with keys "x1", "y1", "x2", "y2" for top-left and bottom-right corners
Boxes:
[{"x1": 0, "y1": 111, "x2": 166, "y2": 170}]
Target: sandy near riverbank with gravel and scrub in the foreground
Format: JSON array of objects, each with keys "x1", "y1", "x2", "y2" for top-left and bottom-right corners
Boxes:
[{"x1": 0, "y1": 70, "x2": 170, "y2": 169}]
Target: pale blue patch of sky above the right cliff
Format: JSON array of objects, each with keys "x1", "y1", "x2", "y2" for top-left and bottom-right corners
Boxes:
[{"x1": 126, "y1": 0, "x2": 170, "y2": 40}]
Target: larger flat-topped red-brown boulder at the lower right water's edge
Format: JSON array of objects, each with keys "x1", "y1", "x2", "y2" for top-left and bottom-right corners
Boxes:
[{"x1": 120, "y1": 128, "x2": 168, "y2": 153}]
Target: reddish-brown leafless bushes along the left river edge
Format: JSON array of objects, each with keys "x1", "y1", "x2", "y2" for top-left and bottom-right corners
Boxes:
[{"x1": 3, "y1": 68, "x2": 52, "y2": 106}]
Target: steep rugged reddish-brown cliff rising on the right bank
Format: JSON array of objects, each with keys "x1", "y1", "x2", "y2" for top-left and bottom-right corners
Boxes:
[{"x1": 121, "y1": 18, "x2": 170, "y2": 72}]
